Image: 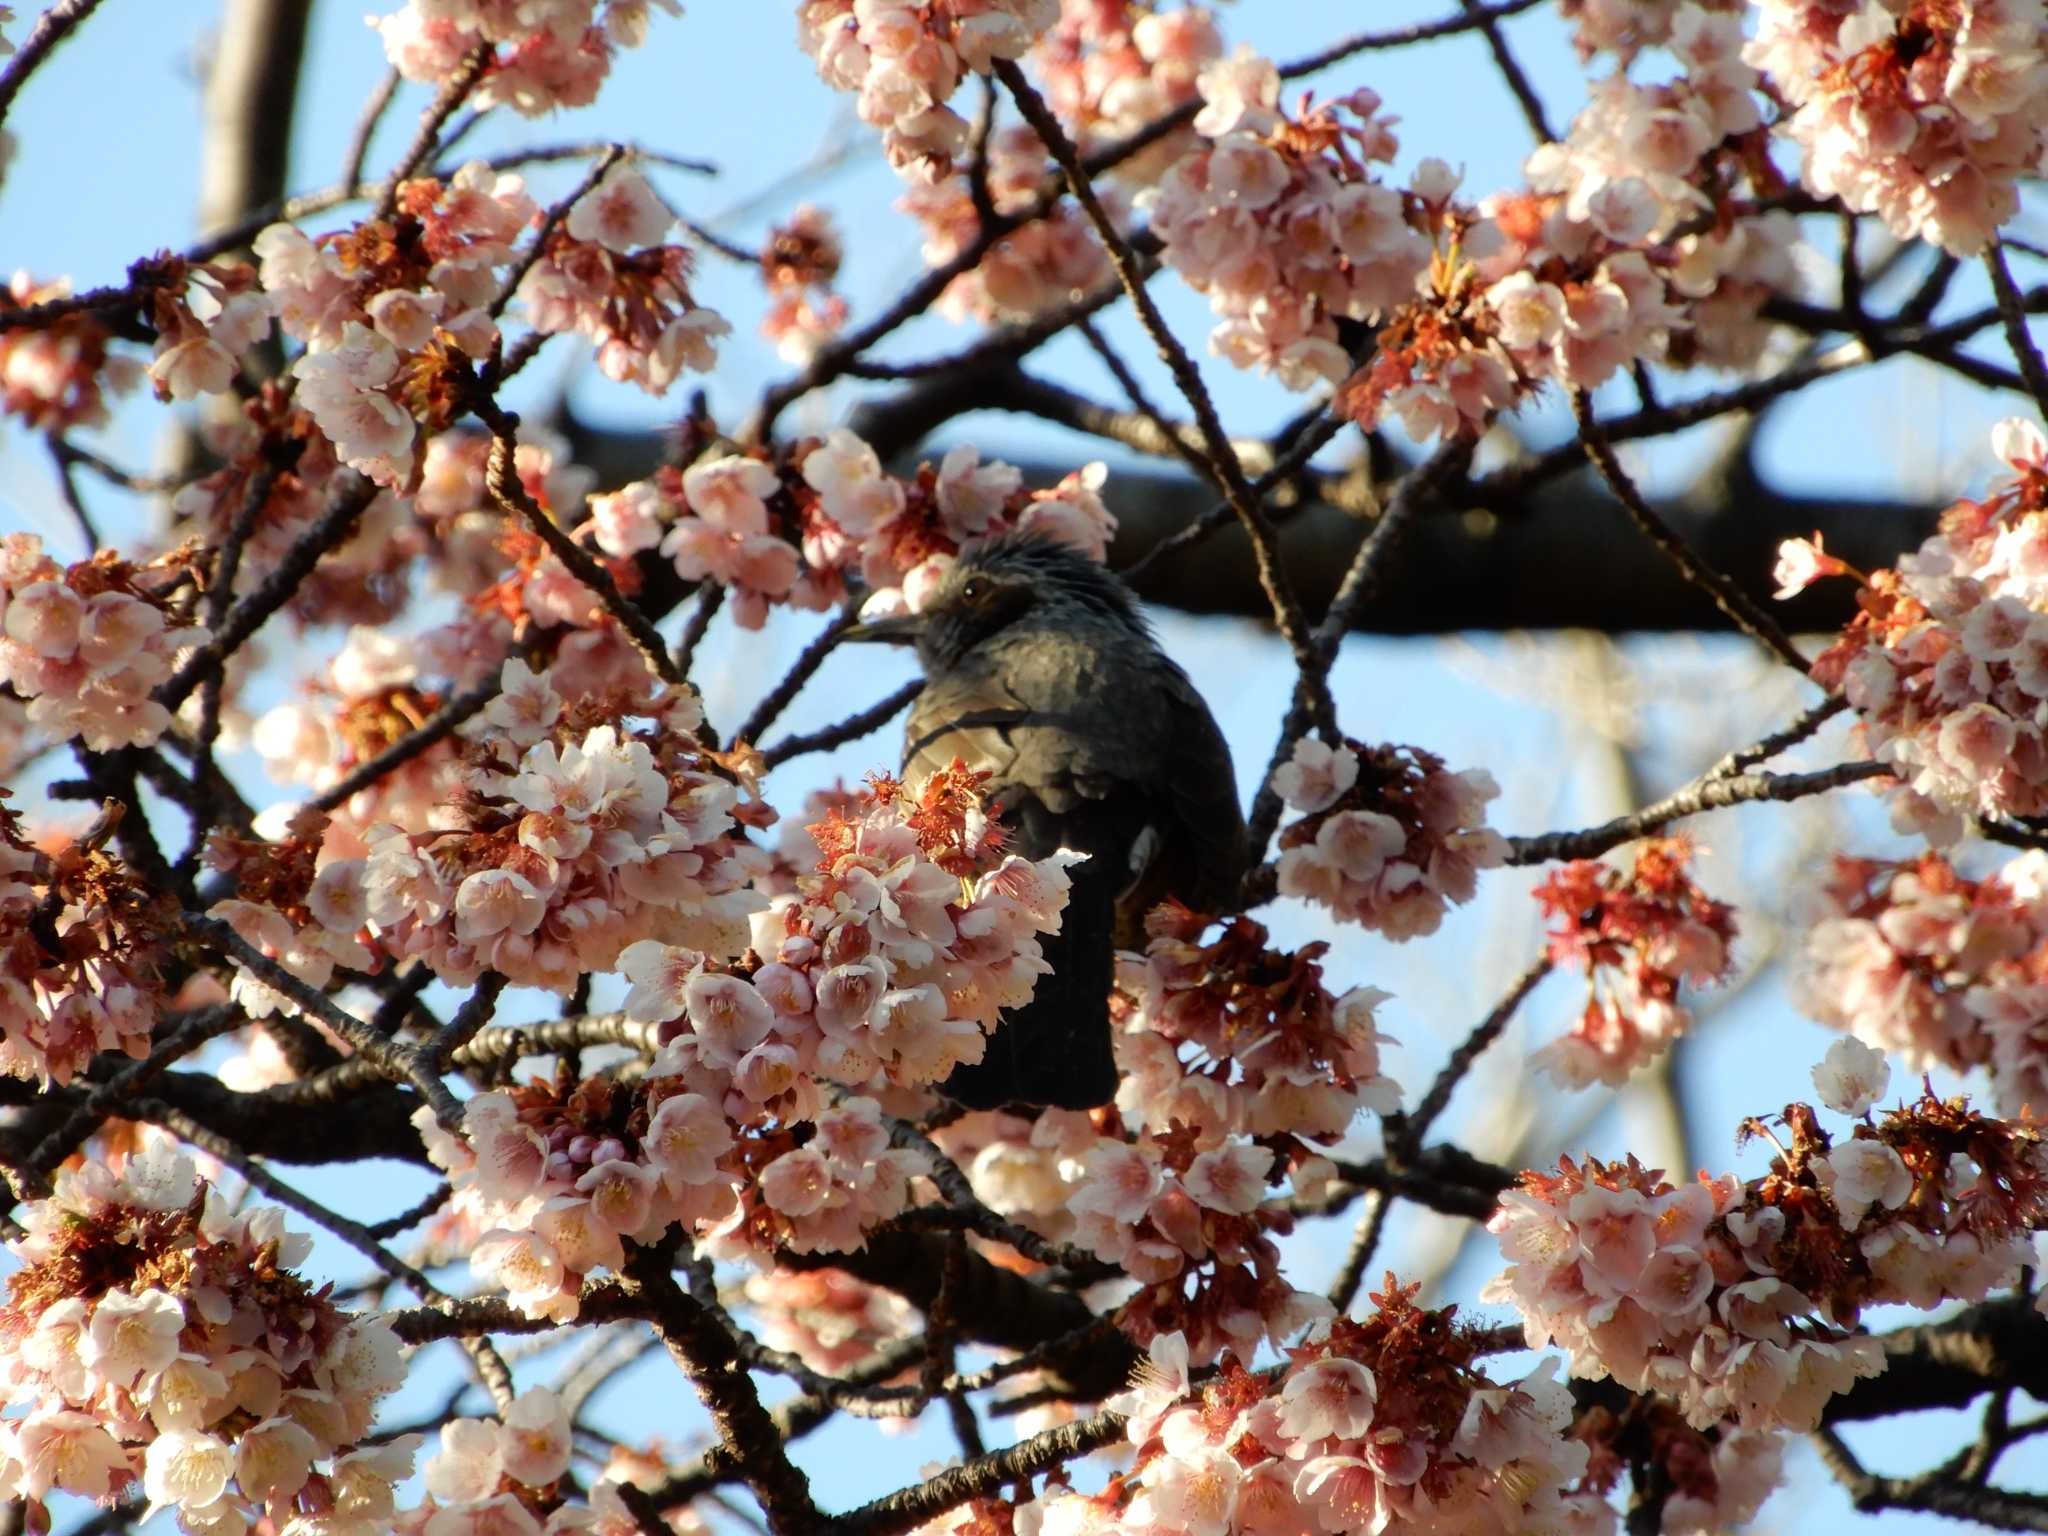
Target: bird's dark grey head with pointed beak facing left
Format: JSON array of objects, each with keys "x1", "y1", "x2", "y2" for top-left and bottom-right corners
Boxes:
[{"x1": 842, "y1": 535, "x2": 1151, "y2": 674}]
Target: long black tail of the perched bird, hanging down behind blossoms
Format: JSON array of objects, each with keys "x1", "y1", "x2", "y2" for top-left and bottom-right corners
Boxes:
[{"x1": 944, "y1": 843, "x2": 1126, "y2": 1110}]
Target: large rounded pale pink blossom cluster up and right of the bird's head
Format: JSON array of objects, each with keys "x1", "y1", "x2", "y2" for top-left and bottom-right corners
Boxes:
[{"x1": 1143, "y1": 57, "x2": 1450, "y2": 389}]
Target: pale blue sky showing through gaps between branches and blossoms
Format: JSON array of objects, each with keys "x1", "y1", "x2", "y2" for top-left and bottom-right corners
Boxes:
[{"x1": 0, "y1": 0, "x2": 2048, "y2": 1530}]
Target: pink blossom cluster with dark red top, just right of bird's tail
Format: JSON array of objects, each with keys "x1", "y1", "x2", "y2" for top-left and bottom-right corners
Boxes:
[{"x1": 1114, "y1": 905, "x2": 1401, "y2": 1145}]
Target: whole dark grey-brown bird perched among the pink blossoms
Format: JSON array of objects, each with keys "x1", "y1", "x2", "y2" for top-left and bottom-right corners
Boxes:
[{"x1": 846, "y1": 532, "x2": 1247, "y2": 1110}]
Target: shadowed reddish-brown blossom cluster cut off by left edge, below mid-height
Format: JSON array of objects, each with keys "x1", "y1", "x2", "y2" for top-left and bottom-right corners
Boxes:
[{"x1": 0, "y1": 793, "x2": 176, "y2": 1085}]
